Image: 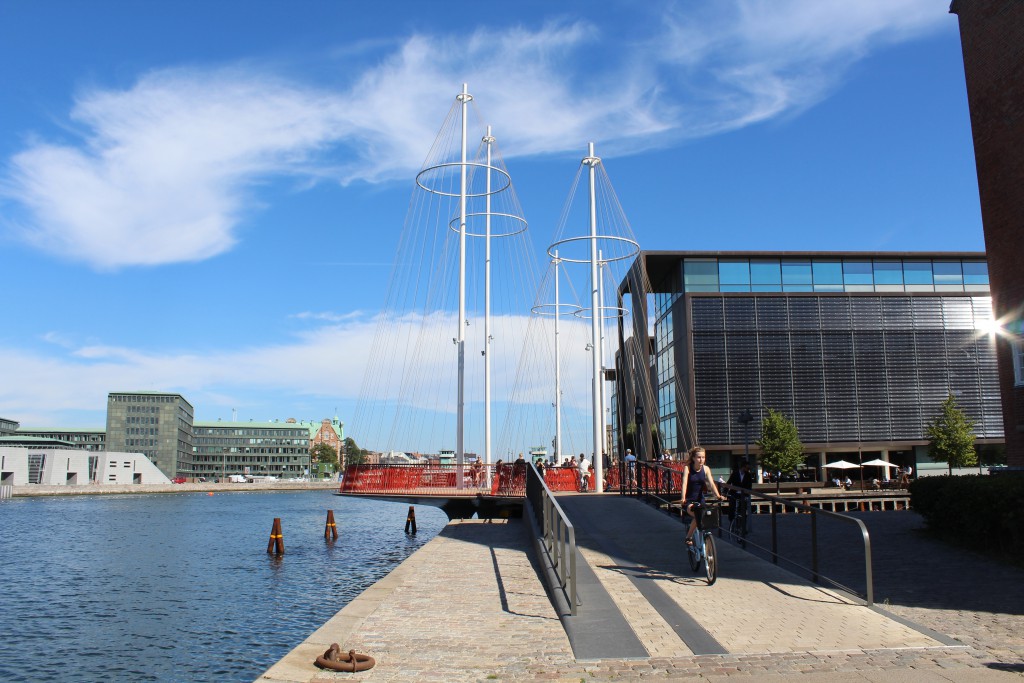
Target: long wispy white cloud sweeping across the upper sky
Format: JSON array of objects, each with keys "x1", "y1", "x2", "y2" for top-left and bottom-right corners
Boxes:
[{"x1": 0, "y1": 0, "x2": 948, "y2": 269}]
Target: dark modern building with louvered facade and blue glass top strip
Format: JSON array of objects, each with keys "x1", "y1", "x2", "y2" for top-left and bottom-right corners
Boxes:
[{"x1": 613, "y1": 252, "x2": 1004, "y2": 477}]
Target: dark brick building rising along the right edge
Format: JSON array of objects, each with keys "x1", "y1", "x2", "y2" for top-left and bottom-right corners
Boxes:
[{"x1": 949, "y1": 0, "x2": 1024, "y2": 467}]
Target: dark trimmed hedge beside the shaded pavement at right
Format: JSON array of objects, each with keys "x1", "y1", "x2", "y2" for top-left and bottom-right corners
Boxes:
[{"x1": 908, "y1": 474, "x2": 1024, "y2": 565}]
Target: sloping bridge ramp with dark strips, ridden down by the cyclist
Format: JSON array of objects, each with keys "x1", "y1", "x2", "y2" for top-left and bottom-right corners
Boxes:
[{"x1": 558, "y1": 494, "x2": 957, "y2": 657}]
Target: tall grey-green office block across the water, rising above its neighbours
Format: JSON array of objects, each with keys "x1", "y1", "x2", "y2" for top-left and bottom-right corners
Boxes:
[{"x1": 106, "y1": 391, "x2": 194, "y2": 478}]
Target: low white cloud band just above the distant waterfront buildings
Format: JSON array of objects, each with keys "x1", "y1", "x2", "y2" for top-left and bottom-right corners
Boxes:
[{"x1": 0, "y1": 312, "x2": 588, "y2": 430}]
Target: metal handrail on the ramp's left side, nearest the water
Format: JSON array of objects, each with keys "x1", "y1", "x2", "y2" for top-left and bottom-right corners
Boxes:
[{"x1": 526, "y1": 463, "x2": 578, "y2": 616}]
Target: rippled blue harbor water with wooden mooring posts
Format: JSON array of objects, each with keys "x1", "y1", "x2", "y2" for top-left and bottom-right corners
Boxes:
[{"x1": 0, "y1": 490, "x2": 446, "y2": 682}]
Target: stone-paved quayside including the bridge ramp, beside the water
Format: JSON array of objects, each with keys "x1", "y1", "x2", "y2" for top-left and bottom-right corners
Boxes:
[{"x1": 260, "y1": 495, "x2": 1024, "y2": 682}]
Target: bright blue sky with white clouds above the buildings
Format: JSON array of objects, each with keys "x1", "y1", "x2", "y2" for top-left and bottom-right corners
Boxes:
[{"x1": 0, "y1": 0, "x2": 984, "y2": 439}]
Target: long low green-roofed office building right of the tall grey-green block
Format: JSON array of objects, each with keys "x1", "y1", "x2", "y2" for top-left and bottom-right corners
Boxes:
[{"x1": 192, "y1": 421, "x2": 309, "y2": 478}]
